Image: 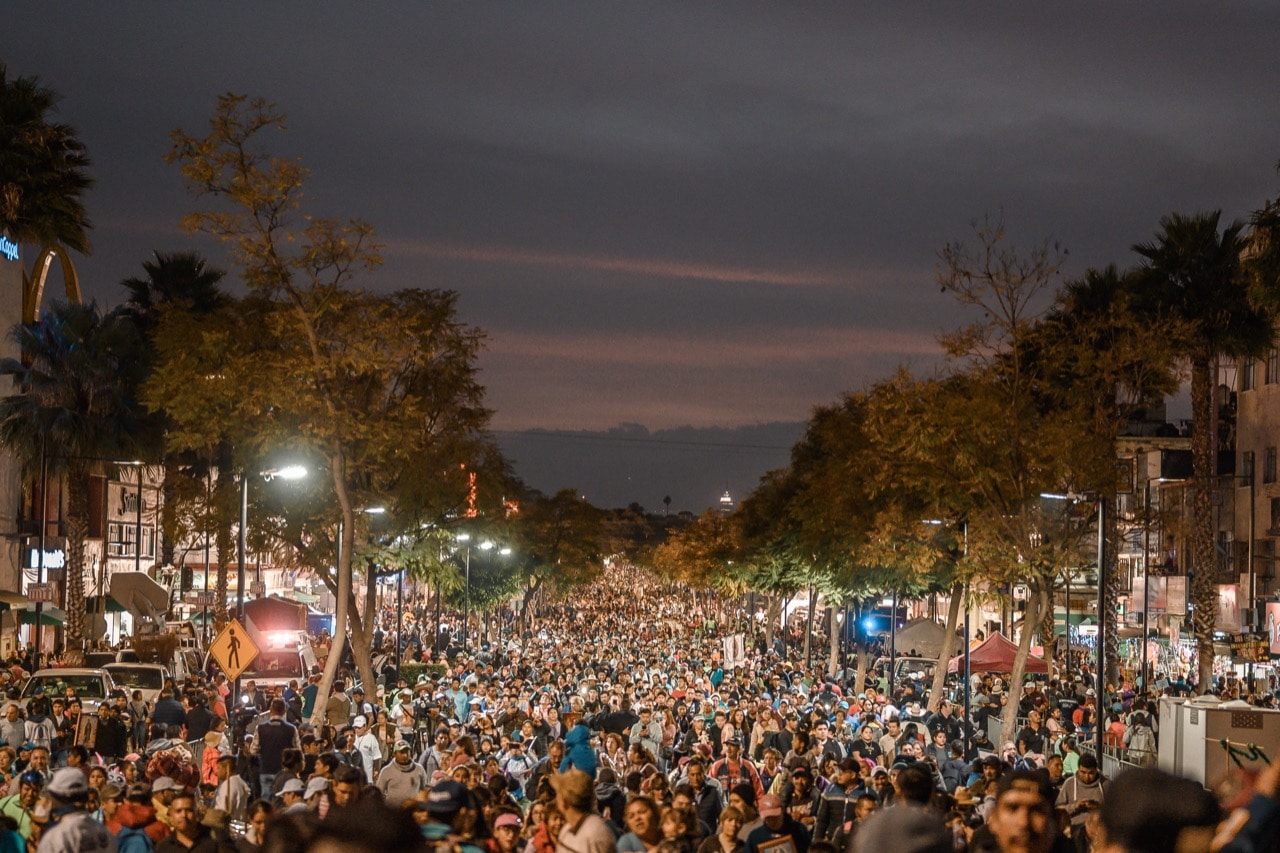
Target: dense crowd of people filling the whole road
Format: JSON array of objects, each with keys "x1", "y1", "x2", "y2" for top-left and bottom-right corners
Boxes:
[{"x1": 0, "y1": 560, "x2": 1280, "y2": 853}]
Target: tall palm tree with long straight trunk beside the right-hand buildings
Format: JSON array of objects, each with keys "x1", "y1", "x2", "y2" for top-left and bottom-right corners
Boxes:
[{"x1": 1133, "y1": 211, "x2": 1280, "y2": 690}]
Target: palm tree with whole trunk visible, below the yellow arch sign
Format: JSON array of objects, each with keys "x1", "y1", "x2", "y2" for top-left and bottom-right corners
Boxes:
[{"x1": 0, "y1": 304, "x2": 146, "y2": 656}]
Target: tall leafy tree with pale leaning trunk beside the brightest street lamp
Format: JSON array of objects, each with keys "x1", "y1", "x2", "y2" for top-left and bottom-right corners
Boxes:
[{"x1": 147, "y1": 95, "x2": 489, "y2": 708}]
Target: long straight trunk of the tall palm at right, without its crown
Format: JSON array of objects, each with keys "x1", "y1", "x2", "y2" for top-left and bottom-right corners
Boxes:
[{"x1": 1190, "y1": 359, "x2": 1217, "y2": 693}]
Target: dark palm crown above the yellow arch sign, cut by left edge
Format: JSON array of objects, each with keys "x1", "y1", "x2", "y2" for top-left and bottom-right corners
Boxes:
[{"x1": 0, "y1": 64, "x2": 93, "y2": 323}]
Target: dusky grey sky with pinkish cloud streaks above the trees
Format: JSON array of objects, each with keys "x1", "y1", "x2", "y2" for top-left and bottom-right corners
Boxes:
[{"x1": 10, "y1": 0, "x2": 1280, "y2": 508}]
